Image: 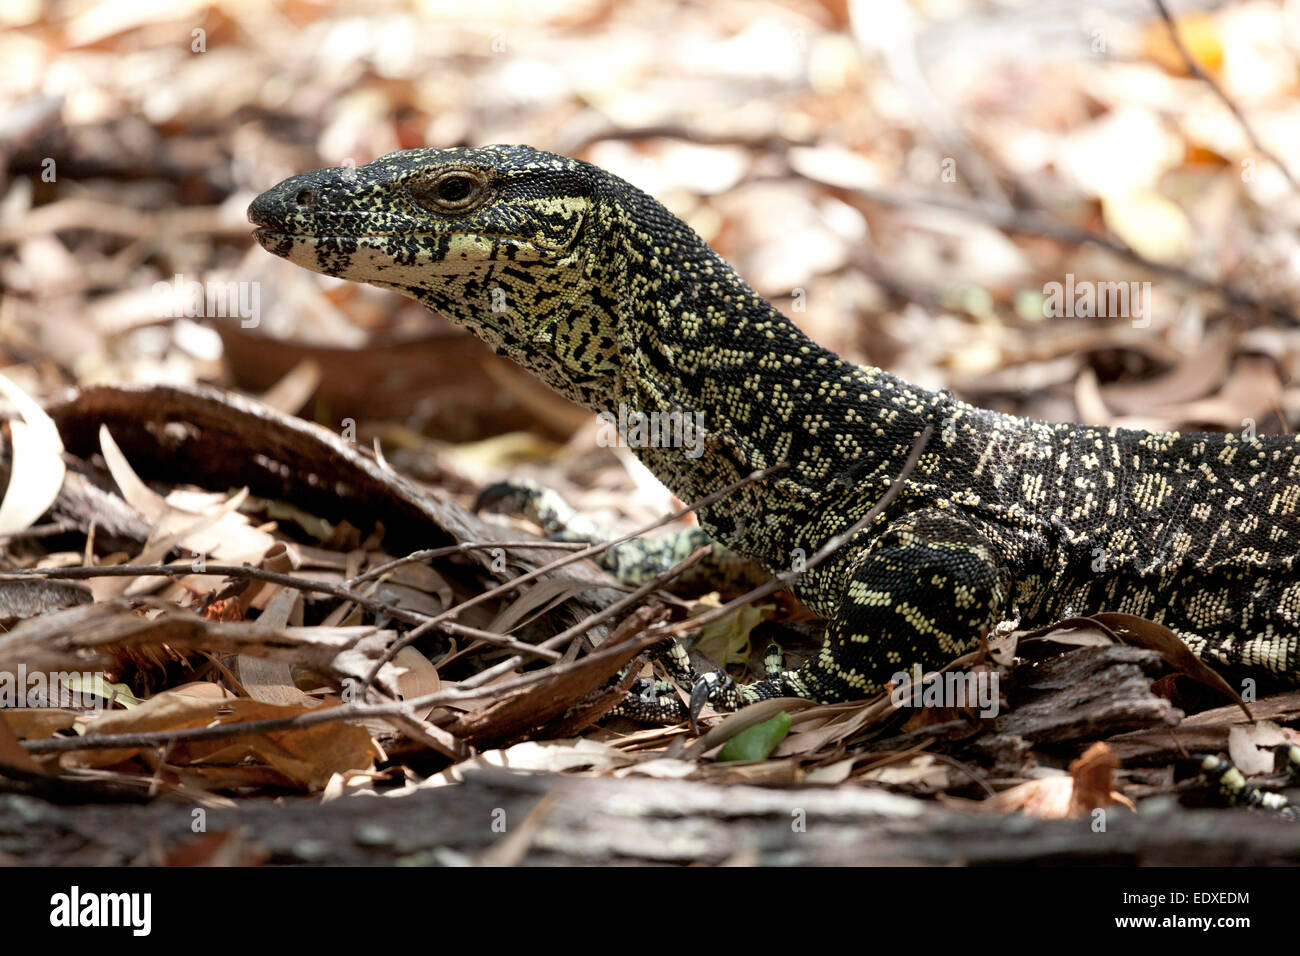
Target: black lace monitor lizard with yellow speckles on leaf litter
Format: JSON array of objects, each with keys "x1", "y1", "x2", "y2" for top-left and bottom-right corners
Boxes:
[{"x1": 248, "y1": 146, "x2": 1300, "y2": 723}]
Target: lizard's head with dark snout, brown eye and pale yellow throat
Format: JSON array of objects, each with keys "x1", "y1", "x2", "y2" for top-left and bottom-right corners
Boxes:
[{"x1": 248, "y1": 146, "x2": 629, "y2": 403}]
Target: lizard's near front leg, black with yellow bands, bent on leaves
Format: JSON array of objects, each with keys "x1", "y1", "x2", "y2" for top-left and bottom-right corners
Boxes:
[{"x1": 736, "y1": 509, "x2": 1004, "y2": 704}]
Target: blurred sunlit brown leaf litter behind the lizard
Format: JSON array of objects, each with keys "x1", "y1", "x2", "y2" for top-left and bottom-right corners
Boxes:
[{"x1": 0, "y1": 0, "x2": 1300, "y2": 519}]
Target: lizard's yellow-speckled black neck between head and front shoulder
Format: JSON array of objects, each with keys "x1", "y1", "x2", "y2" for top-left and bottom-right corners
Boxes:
[{"x1": 595, "y1": 200, "x2": 950, "y2": 567}]
